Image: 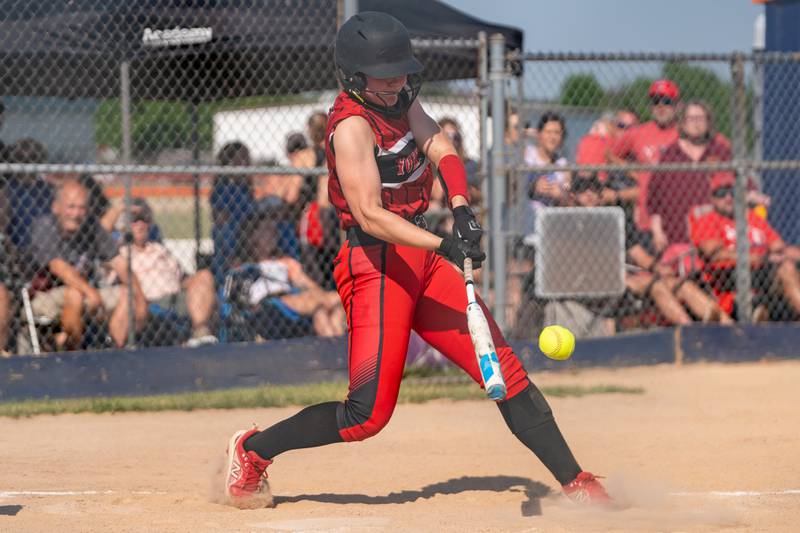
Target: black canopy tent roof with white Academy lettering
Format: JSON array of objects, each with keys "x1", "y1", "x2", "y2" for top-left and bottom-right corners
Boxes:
[{"x1": 0, "y1": 0, "x2": 522, "y2": 101}]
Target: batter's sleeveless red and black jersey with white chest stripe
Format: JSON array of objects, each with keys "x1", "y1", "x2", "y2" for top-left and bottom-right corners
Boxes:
[{"x1": 325, "y1": 93, "x2": 433, "y2": 229}]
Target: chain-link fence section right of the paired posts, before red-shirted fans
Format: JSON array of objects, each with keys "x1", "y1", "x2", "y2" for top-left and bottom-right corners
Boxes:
[{"x1": 504, "y1": 50, "x2": 800, "y2": 338}]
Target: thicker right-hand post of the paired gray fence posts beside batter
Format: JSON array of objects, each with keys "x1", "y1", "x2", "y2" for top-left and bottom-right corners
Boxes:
[{"x1": 489, "y1": 33, "x2": 506, "y2": 331}]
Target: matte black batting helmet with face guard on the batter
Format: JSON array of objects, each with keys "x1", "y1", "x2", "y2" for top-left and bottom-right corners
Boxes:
[{"x1": 335, "y1": 11, "x2": 423, "y2": 116}]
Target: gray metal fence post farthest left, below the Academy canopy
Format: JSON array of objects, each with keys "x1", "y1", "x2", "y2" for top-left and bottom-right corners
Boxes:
[{"x1": 119, "y1": 61, "x2": 136, "y2": 347}]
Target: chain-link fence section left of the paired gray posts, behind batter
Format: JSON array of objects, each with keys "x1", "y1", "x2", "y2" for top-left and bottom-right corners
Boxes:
[{"x1": 0, "y1": 0, "x2": 494, "y2": 353}]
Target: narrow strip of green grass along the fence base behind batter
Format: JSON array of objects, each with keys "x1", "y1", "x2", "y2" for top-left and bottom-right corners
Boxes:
[{"x1": 0, "y1": 380, "x2": 644, "y2": 418}]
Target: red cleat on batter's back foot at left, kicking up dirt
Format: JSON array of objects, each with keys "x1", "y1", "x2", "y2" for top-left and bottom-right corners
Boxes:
[{"x1": 225, "y1": 428, "x2": 274, "y2": 509}]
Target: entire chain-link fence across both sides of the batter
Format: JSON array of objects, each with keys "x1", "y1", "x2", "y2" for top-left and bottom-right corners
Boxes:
[{"x1": 6, "y1": 4, "x2": 800, "y2": 353}]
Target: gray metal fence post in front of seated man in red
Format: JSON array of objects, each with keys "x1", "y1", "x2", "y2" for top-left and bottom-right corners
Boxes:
[{"x1": 731, "y1": 54, "x2": 753, "y2": 324}]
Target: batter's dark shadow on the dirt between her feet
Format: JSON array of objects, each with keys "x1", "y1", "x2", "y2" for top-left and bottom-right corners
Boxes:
[{"x1": 275, "y1": 476, "x2": 551, "y2": 516}]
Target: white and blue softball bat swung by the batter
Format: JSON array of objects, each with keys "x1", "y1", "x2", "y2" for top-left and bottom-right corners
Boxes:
[{"x1": 464, "y1": 258, "x2": 506, "y2": 400}]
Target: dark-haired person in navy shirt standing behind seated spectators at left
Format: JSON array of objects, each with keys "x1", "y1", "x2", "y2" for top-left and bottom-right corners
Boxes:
[{"x1": 209, "y1": 141, "x2": 256, "y2": 286}]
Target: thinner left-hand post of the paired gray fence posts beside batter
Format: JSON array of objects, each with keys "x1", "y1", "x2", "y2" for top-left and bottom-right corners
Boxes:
[{"x1": 478, "y1": 31, "x2": 494, "y2": 294}]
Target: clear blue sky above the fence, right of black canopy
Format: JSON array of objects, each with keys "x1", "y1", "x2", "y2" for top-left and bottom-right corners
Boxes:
[{"x1": 443, "y1": 0, "x2": 764, "y2": 52}]
